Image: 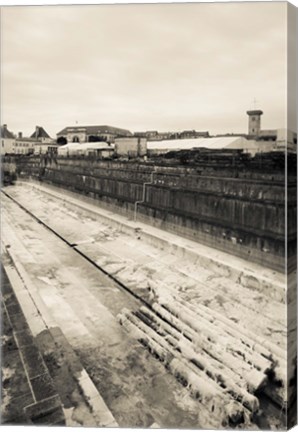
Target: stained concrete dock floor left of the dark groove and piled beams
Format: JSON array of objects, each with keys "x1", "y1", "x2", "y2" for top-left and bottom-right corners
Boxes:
[{"x1": 3, "y1": 192, "x2": 218, "y2": 428}]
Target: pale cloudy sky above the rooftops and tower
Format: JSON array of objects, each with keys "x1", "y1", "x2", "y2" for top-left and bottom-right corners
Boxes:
[{"x1": 1, "y1": 3, "x2": 286, "y2": 137}]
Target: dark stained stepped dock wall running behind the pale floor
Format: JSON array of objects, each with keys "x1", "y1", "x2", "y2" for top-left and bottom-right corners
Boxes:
[{"x1": 12, "y1": 157, "x2": 296, "y2": 271}]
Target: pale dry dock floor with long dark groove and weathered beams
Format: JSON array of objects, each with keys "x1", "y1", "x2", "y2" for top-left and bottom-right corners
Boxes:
[{"x1": 2, "y1": 182, "x2": 287, "y2": 429}]
